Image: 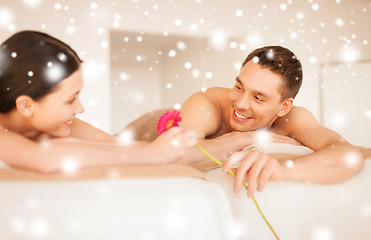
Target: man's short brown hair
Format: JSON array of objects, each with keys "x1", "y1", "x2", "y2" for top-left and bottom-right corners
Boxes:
[{"x1": 242, "y1": 46, "x2": 303, "y2": 100}]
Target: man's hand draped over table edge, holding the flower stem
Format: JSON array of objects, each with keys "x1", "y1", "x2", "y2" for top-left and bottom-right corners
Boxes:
[{"x1": 222, "y1": 150, "x2": 284, "y2": 198}]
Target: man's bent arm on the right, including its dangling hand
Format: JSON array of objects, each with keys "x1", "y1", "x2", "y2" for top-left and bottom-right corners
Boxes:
[{"x1": 223, "y1": 109, "x2": 364, "y2": 197}]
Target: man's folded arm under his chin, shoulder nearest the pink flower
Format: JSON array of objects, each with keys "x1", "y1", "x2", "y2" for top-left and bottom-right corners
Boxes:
[{"x1": 178, "y1": 89, "x2": 302, "y2": 171}]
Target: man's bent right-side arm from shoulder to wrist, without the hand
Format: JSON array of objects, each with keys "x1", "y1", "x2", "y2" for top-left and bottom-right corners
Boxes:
[{"x1": 276, "y1": 108, "x2": 364, "y2": 184}]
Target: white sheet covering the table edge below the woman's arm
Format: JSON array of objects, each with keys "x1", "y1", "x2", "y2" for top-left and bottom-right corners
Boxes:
[{"x1": 0, "y1": 177, "x2": 235, "y2": 240}]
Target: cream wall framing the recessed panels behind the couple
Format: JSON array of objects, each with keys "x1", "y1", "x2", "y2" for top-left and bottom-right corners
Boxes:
[{"x1": 0, "y1": 0, "x2": 371, "y2": 135}]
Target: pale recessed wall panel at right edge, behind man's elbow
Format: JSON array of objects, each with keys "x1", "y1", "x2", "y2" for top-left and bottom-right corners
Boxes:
[{"x1": 320, "y1": 60, "x2": 371, "y2": 147}]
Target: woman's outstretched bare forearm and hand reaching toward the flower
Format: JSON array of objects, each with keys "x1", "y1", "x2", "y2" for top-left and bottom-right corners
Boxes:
[{"x1": 0, "y1": 124, "x2": 195, "y2": 173}]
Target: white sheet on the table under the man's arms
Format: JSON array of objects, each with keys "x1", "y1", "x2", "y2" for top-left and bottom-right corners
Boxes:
[{"x1": 207, "y1": 144, "x2": 371, "y2": 240}]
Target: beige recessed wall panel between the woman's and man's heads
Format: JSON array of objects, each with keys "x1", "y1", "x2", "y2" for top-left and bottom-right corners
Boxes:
[{"x1": 110, "y1": 31, "x2": 241, "y2": 133}]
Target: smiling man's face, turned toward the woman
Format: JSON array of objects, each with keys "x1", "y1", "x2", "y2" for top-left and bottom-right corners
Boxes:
[{"x1": 229, "y1": 61, "x2": 283, "y2": 131}]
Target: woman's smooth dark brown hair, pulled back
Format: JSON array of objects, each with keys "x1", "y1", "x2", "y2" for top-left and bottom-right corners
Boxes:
[{"x1": 0, "y1": 31, "x2": 82, "y2": 113}]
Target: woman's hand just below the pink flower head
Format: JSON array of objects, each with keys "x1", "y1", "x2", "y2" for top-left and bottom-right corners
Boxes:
[{"x1": 148, "y1": 127, "x2": 197, "y2": 164}]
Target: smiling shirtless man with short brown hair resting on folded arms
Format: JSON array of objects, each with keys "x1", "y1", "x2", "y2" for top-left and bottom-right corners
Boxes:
[{"x1": 181, "y1": 46, "x2": 364, "y2": 197}]
